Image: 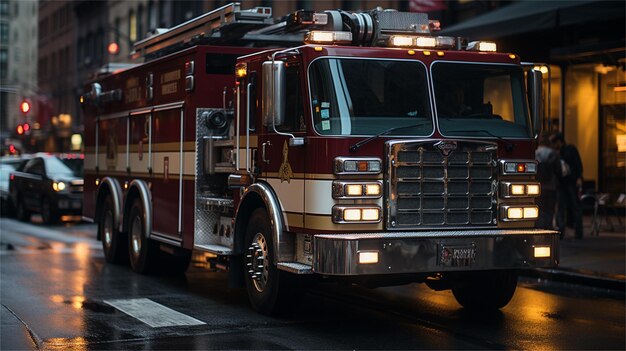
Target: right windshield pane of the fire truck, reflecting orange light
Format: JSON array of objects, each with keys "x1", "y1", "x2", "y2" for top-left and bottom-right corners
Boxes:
[{"x1": 432, "y1": 62, "x2": 531, "y2": 138}]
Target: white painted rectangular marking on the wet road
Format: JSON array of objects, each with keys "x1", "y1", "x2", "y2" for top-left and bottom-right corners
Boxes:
[{"x1": 103, "y1": 298, "x2": 206, "y2": 328}]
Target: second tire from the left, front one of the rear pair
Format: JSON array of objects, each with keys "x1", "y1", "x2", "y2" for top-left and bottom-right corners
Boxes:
[{"x1": 127, "y1": 199, "x2": 160, "y2": 274}]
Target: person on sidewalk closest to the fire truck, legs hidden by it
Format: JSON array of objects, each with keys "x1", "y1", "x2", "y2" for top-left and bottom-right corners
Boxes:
[{"x1": 535, "y1": 134, "x2": 562, "y2": 230}]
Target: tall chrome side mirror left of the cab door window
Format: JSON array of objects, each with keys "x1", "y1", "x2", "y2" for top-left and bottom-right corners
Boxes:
[{"x1": 263, "y1": 61, "x2": 286, "y2": 126}]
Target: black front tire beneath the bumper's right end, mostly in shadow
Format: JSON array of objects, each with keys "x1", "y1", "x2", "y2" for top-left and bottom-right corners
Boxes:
[{"x1": 452, "y1": 270, "x2": 517, "y2": 310}]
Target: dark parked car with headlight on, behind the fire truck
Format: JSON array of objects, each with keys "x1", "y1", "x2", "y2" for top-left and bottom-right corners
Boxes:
[{"x1": 9, "y1": 154, "x2": 83, "y2": 223}]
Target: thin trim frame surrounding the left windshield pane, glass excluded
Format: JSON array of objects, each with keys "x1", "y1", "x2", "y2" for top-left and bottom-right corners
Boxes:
[{"x1": 304, "y1": 55, "x2": 437, "y2": 138}]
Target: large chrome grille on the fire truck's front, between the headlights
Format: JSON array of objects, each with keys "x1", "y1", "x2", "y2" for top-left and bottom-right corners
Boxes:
[{"x1": 387, "y1": 140, "x2": 497, "y2": 230}]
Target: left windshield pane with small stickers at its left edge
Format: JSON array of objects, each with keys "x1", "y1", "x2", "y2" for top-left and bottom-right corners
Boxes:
[{"x1": 309, "y1": 58, "x2": 433, "y2": 136}]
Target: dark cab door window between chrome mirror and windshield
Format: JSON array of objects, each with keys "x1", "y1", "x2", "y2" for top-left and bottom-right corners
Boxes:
[{"x1": 277, "y1": 64, "x2": 306, "y2": 132}]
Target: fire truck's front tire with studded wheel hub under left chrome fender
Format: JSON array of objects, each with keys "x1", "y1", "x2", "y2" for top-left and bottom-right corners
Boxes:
[{"x1": 244, "y1": 208, "x2": 289, "y2": 315}]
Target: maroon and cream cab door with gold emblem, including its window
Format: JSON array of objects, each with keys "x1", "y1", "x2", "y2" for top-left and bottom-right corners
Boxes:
[{"x1": 258, "y1": 59, "x2": 307, "y2": 231}]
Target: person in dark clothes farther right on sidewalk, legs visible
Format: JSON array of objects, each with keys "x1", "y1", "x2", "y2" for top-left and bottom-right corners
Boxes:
[{"x1": 550, "y1": 133, "x2": 583, "y2": 239}]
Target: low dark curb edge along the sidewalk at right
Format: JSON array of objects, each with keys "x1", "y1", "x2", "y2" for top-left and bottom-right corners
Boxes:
[{"x1": 520, "y1": 268, "x2": 626, "y2": 292}]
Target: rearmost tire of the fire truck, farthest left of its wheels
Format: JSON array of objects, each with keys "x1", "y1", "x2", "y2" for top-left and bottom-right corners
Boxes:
[{"x1": 98, "y1": 196, "x2": 128, "y2": 264}]
